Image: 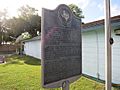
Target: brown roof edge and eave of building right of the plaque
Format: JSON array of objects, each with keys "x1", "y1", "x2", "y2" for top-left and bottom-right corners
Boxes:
[{"x1": 81, "y1": 15, "x2": 120, "y2": 31}]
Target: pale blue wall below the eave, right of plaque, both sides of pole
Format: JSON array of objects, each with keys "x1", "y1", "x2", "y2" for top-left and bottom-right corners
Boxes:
[{"x1": 82, "y1": 30, "x2": 120, "y2": 84}]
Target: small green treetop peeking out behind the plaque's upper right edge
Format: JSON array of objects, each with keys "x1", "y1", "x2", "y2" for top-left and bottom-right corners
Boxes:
[{"x1": 68, "y1": 4, "x2": 84, "y2": 18}]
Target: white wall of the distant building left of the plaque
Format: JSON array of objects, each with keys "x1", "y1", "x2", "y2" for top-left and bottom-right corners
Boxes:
[{"x1": 24, "y1": 40, "x2": 41, "y2": 59}]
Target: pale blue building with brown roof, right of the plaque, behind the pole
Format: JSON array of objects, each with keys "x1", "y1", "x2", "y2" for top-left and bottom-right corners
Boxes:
[{"x1": 82, "y1": 15, "x2": 120, "y2": 84}]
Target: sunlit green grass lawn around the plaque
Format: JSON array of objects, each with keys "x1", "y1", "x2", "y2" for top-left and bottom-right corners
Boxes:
[{"x1": 0, "y1": 55, "x2": 120, "y2": 90}]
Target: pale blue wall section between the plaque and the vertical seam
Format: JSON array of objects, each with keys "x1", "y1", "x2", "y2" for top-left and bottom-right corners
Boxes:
[{"x1": 82, "y1": 31, "x2": 97, "y2": 77}]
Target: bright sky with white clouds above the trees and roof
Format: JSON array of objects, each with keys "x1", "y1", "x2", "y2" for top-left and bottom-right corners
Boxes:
[{"x1": 0, "y1": 0, "x2": 120, "y2": 23}]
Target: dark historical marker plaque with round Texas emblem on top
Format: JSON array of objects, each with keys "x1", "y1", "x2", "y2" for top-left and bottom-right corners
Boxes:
[{"x1": 42, "y1": 4, "x2": 82, "y2": 87}]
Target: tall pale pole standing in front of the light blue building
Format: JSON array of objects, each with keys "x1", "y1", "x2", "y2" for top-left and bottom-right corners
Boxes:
[{"x1": 105, "y1": 0, "x2": 112, "y2": 90}]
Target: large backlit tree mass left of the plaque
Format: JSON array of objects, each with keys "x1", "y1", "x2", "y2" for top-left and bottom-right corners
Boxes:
[{"x1": 0, "y1": 5, "x2": 41, "y2": 44}]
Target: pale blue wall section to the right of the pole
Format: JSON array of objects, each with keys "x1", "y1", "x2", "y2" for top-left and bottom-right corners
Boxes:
[{"x1": 112, "y1": 30, "x2": 120, "y2": 84}]
